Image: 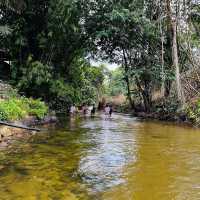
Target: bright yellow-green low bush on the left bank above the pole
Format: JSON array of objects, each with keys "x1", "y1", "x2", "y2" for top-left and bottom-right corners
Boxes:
[{"x1": 0, "y1": 97, "x2": 48, "y2": 121}]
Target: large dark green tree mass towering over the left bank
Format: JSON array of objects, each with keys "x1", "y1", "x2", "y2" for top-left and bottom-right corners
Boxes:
[{"x1": 0, "y1": 0, "x2": 102, "y2": 108}]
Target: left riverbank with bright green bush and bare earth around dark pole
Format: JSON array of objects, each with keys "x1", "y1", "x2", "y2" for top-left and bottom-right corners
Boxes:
[{"x1": 0, "y1": 81, "x2": 57, "y2": 149}]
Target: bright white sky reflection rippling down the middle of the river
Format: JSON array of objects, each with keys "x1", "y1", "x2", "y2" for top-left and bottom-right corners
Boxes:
[{"x1": 79, "y1": 117, "x2": 136, "y2": 192}]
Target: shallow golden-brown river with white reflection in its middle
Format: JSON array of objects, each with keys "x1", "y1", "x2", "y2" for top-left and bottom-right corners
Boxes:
[{"x1": 0, "y1": 114, "x2": 200, "y2": 200}]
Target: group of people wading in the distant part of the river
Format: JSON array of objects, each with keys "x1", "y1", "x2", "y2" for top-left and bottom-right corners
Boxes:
[{"x1": 69, "y1": 104, "x2": 113, "y2": 117}]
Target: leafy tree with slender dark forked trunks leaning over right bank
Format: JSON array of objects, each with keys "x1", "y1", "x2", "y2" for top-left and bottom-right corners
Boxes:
[{"x1": 86, "y1": 1, "x2": 164, "y2": 111}]
